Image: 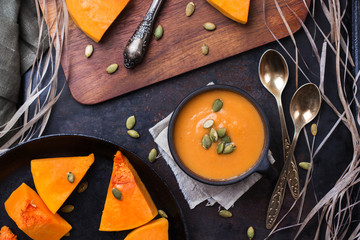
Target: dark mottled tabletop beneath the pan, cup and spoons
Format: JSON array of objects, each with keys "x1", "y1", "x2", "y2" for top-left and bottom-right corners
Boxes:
[{"x1": 22, "y1": 2, "x2": 352, "y2": 240}]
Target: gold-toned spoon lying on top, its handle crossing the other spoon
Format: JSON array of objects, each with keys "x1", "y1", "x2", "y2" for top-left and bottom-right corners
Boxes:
[{"x1": 266, "y1": 83, "x2": 321, "y2": 229}]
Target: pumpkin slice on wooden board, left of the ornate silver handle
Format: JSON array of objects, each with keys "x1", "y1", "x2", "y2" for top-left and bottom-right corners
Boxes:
[{"x1": 66, "y1": 0, "x2": 130, "y2": 42}]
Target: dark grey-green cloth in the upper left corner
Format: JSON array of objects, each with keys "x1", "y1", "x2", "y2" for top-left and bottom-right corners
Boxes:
[{"x1": 0, "y1": 0, "x2": 47, "y2": 145}]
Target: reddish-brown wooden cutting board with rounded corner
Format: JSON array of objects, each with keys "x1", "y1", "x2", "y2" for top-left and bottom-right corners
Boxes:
[{"x1": 40, "y1": 0, "x2": 310, "y2": 104}]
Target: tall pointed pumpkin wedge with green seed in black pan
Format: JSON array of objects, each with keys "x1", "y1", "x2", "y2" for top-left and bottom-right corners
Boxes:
[{"x1": 99, "y1": 151, "x2": 158, "y2": 231}]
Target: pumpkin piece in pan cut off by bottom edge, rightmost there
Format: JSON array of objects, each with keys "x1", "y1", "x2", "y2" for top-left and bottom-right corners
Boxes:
[{"x1": 124, "y1": 218, "x2": 169, "y2": 240}]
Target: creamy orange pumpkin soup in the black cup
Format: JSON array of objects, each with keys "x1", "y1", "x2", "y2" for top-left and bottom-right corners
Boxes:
[{"x1": 173, "y1": 90, "x2": 265, "y2": 181}]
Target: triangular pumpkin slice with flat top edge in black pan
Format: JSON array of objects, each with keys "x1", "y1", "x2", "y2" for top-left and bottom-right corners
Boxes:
[{"x1": 31, "y1": 154, "x2": 94, "y2": 213}]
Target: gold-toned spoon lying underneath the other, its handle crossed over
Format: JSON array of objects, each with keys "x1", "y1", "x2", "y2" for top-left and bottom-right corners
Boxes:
[{"x1": 259, "y1": 49, "x2": 299, "y2": 199}]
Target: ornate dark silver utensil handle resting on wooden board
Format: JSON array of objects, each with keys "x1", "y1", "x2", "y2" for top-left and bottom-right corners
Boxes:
[{"x1": 124, "y1": 0, "x2": 164, "y2": 69}]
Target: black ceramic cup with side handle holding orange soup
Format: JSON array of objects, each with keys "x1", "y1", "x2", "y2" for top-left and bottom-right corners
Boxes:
[{"x1": 168, "y1": 85, "x2": 276, "y2": 185}]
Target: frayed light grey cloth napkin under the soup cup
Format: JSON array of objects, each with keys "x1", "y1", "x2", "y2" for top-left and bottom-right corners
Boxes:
[{"x1": 149, "y1": 113, "x2": 275, "y2": 209}]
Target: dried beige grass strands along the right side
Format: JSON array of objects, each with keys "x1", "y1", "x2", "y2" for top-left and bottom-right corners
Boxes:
[{"x1": 263, "y1": 0, "x2": 360, "y2": 239}]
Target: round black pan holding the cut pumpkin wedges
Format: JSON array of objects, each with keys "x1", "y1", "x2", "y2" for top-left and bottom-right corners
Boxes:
[{"x1": 0, "y1": 135, "x2": 188, "y2": 240}]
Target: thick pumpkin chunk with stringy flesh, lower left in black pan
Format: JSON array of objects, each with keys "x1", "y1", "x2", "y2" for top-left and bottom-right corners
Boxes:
[{"x1": 5, "y1": 183, "x2": 71, "y2": 240}]
